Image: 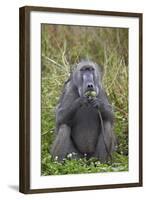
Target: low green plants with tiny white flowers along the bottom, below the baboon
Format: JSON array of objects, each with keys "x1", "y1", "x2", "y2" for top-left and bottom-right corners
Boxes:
[{"x1": 42, "y1": 153, "x2": 128, "y2": 175}]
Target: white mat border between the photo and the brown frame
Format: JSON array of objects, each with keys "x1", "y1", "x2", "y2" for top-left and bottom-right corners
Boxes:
[{"x1": 30, "y1": 11, "x2": 139, "y2": 189}]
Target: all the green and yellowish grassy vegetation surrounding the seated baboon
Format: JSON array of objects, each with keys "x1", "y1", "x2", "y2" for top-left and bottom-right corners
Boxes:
[{"x1": 41, "y1": 24, "x2": 128, "y2": 175}]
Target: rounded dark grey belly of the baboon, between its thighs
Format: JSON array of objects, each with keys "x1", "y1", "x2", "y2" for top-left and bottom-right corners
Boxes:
[{"x1": 71, "y1": 106, "x2": 100, "y2": 154}]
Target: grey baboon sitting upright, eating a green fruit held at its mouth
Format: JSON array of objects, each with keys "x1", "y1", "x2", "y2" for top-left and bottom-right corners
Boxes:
[{"x1": 51, "y1": 60, "x2": 115, "y2": 162}]
